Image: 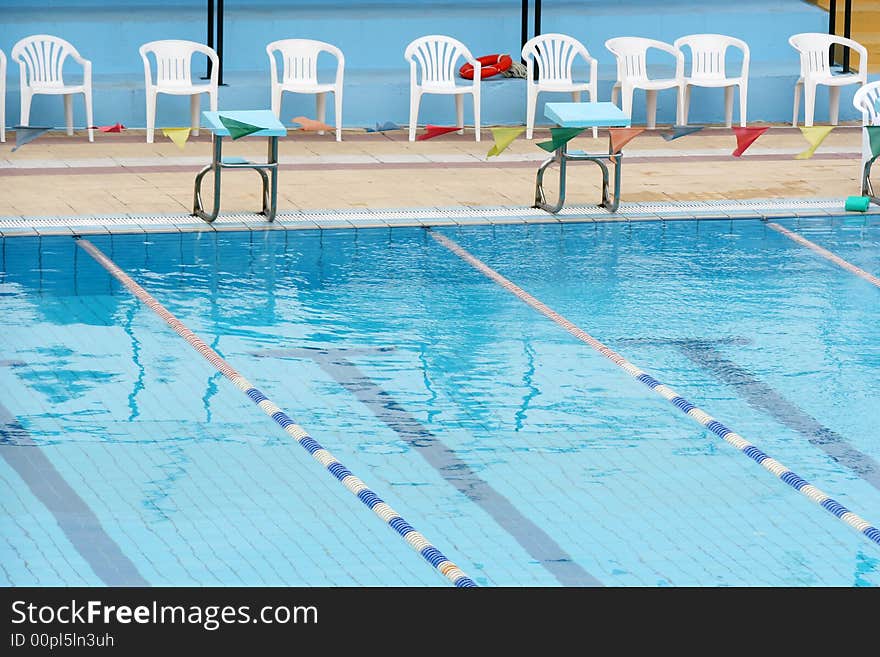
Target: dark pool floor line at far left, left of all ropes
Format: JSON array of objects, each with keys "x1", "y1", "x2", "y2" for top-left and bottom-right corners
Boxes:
[{"x1": 0, "y1": 404, "x2": 150, "y2": 586}]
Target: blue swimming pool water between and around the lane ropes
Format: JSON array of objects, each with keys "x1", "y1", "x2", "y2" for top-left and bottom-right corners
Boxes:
[{"x1": 0, "y1": 217, "x2": 880, "y2": 587}]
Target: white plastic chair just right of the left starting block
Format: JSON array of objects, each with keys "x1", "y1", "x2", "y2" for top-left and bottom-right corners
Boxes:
[{"x1": 266, "y1": 39, "x2": 345, "y2": 141}]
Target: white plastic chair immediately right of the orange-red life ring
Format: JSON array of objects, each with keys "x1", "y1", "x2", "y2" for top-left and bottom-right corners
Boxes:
[{"x1": 522, "y1": 34, "x2": 599, "y2": 139}]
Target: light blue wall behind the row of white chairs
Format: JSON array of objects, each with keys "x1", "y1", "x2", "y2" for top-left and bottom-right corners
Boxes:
[{"x1": 0, "y1": 0, "x2": 858, "y2": 128}]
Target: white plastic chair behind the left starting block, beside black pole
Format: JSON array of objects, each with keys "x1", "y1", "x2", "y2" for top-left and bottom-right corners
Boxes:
[{"x1": 138, "y1": 39, "x2": 220, "y2": 144}]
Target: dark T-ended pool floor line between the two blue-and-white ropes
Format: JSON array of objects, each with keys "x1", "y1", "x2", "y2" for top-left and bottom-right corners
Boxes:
[{"x1": 255, "y1": 348, "x2": 602, "y2": 587}]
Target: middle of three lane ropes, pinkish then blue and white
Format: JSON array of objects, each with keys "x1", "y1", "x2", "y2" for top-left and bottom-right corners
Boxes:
[{"x1": 429, "y1": 231, "x2": 880, "y2": 545}]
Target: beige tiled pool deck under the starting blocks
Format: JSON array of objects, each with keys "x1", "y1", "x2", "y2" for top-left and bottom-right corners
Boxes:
[{"x1": 0, "y1": 124, "x2": 880, "y2": 236}]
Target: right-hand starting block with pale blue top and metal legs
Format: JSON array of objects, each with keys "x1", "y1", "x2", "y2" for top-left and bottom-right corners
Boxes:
[{"x1": 532, "y1": 102, "x2": 630, "y2": 214}]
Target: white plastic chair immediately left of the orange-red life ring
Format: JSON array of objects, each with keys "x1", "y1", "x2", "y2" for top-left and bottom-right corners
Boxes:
[{"x1": 403, "y1": 34, "x2": 482, "y2": 141}]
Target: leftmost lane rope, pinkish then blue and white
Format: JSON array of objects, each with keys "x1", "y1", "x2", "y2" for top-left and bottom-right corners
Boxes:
[{"x1": 77, "y1": 239, "x2": 476, "y2": 587}]
